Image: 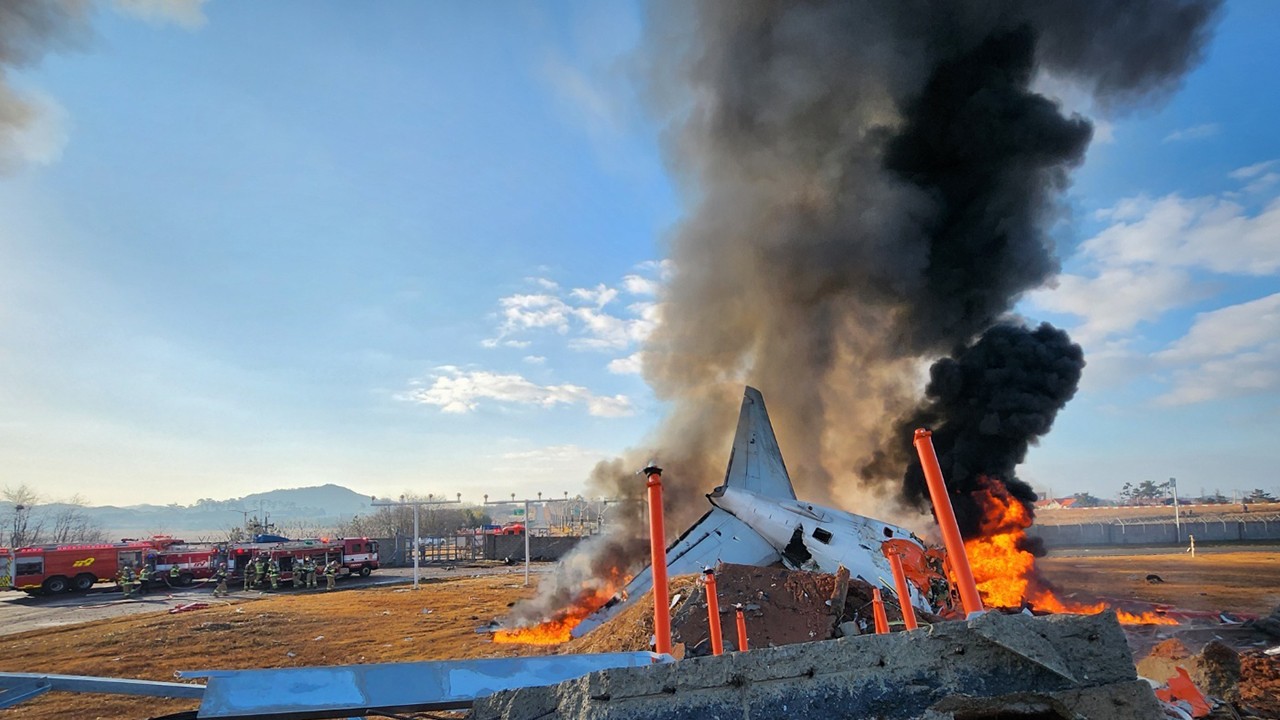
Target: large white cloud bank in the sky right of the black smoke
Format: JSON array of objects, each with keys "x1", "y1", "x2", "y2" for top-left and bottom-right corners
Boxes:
[{"x1": 1028, "y1": 174, "x2": 1280, "y2": 405}]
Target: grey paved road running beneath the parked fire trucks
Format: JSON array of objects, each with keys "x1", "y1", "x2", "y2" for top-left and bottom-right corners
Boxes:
[{"x1": 0, "y1": 562, "x2": 553, "y2": 635}]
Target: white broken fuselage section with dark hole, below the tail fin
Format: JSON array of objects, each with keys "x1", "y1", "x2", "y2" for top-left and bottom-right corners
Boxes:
[{"x1": 707, "y1": 487, "x2": 933, "y2": 611}]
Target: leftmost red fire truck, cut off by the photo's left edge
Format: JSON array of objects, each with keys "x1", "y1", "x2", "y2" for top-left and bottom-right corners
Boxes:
[{"x1": 0, "y1": 537, "x2": 182, "y2": 594}]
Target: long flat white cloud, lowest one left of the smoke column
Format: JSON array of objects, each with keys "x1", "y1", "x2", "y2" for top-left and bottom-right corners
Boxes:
[{"x1": 407, "y1": 365, "x2": 632, "y2": 418}]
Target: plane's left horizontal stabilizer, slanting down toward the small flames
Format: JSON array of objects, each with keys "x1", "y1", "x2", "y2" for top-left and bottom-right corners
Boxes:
[{"x1": 573, "y1": 507, "x2": 782, "y2": 638}]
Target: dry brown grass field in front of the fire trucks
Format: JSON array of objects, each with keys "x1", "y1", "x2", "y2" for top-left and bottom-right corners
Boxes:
[{"x1": 0, "y1": 578, "x2": 553, "y2": 719}]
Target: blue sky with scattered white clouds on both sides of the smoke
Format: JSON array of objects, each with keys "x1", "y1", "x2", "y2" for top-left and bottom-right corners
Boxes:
[{"x1": 0, "y1": 0, "x2": 1280, "y2": 505}]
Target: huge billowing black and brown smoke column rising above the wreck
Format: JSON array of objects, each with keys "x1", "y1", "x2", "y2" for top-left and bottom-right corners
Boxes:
[{"x1": 509, "y1": 0, "x2": 1219, "y2": 622}]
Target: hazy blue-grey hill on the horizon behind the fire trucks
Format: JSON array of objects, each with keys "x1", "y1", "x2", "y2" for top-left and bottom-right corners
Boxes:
[{"x1": 0, "y1": 484, "x2": 370, "y2": 539}]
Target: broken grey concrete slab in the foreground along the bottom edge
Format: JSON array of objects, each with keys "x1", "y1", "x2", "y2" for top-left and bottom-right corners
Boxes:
[{"x1": 471, "y1": 604, "x2": 1164, "y2": 720}]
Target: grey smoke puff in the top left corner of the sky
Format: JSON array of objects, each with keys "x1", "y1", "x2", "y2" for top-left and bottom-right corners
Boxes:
[{"x1": 0, "y1": 0, "x2": 90, "y2": 172}]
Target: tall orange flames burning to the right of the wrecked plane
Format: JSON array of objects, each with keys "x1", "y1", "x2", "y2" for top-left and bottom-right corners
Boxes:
[{"x1": 965, "y1": 478, "x2": 1178, "y2": 625}]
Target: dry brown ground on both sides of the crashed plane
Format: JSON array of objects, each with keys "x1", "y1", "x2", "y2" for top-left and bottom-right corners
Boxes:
[{"x1": 0, "y1": 550, "x2": 1280, "y2": 719}]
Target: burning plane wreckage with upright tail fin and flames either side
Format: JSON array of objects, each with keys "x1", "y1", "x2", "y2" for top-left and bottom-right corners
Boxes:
[{"x1": 494, "y1": 387, "x2": 1178, "y2": 644}]
